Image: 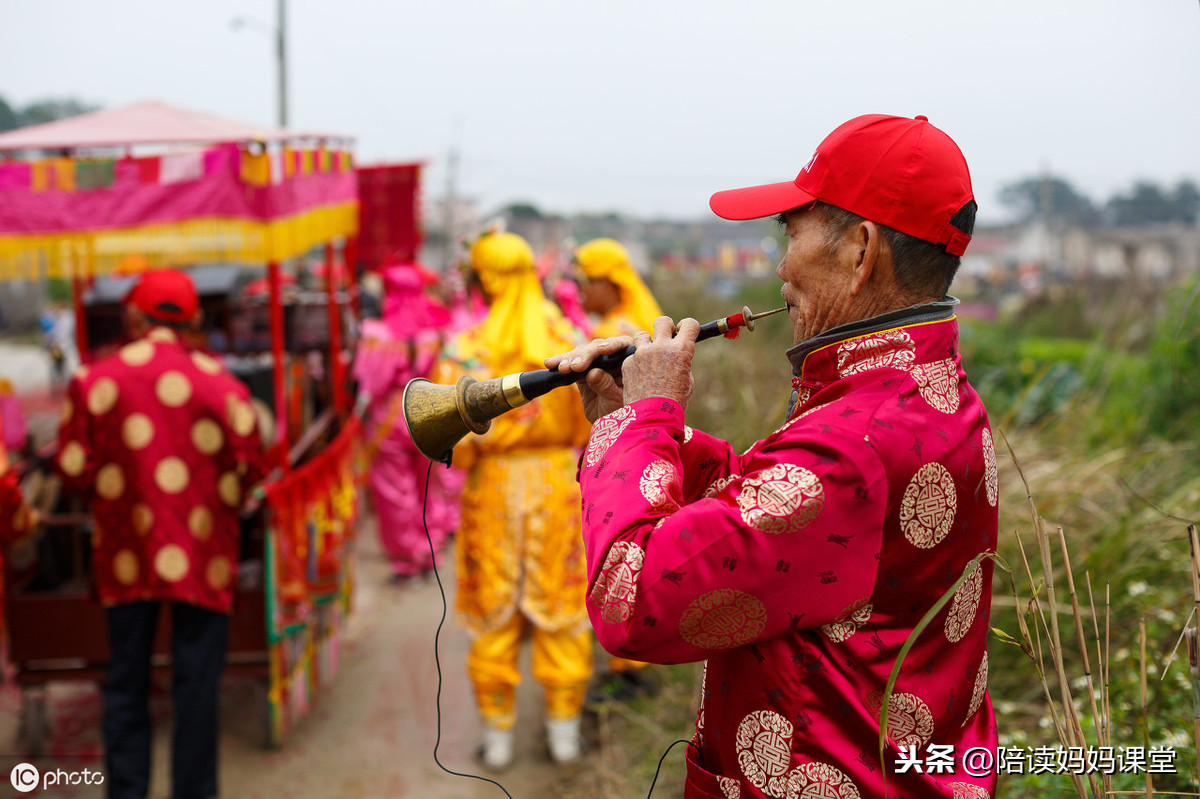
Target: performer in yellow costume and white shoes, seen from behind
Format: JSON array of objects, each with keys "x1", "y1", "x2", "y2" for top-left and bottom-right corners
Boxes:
[{"x1": 431, "y1": 233, "x2": 593, "y2": 770}]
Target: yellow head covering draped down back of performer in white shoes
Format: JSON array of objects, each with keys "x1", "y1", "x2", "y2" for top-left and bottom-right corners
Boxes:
[{"x1": 470, "y1": 233, "x2": 562, "y2": 376}]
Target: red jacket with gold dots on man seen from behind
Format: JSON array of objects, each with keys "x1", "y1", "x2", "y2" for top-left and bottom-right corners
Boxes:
[{"x1": 58, "y1": 328, "x2": 262, "y2": 613}]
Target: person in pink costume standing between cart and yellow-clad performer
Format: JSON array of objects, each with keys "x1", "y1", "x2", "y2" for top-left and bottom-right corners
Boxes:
[{"x1": 354, "y1": 264, "x2": 463, "y2": 577}]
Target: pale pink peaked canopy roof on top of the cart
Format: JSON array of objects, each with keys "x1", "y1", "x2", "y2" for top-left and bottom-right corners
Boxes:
[{"x1": 0, "y1": 101, "x2": 353, "y2": 152}]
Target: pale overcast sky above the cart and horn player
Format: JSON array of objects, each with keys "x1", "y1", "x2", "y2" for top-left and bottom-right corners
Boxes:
[{"x1": 0, "y1": 0, "x2": 1200, "y2": 222}]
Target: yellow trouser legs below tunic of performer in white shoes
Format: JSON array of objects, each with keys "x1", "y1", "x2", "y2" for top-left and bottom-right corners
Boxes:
[{"x1": 467, "y1": 613, "x2": 592, "y2": 729}]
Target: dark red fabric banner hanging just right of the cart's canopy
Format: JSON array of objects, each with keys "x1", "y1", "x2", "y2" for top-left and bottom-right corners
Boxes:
[{"x1": 358, "y1": 163, "x2": 421, "y2": 269}]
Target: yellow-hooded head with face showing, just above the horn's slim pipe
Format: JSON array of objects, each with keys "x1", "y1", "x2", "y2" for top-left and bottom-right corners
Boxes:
[{"x1": 575, "y1": 239, "x2": 662, "y2": 338}]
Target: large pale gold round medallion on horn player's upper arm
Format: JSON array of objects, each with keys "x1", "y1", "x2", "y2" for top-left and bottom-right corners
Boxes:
[{"x1": 738, "y1": 463, "x2": 824, "y2": 535}]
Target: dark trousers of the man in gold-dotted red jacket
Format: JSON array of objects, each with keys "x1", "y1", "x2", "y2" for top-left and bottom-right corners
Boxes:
[{"x1": 103, "y1": 602, "x2": 229, "y2": 799}]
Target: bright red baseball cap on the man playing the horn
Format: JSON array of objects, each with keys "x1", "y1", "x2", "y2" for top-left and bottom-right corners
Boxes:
[{"x1": 708, "y1": 114, "x2": 974, "y2": 256}]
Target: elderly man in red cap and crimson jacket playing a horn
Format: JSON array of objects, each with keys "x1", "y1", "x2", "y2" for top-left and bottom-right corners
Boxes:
[{"x1": 546, "y1": 115, "x2": 997, "y2": 798}]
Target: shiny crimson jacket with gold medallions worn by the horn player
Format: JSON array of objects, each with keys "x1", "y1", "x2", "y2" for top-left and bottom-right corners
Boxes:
[{"x1": 580, "y1": 312, "x2": 997, "y2": 799}]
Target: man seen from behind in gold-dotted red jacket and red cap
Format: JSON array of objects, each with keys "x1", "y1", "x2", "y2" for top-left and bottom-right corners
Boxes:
[{"x1": 58, "y1": 270, "x2": 263, "y2": 799}]
